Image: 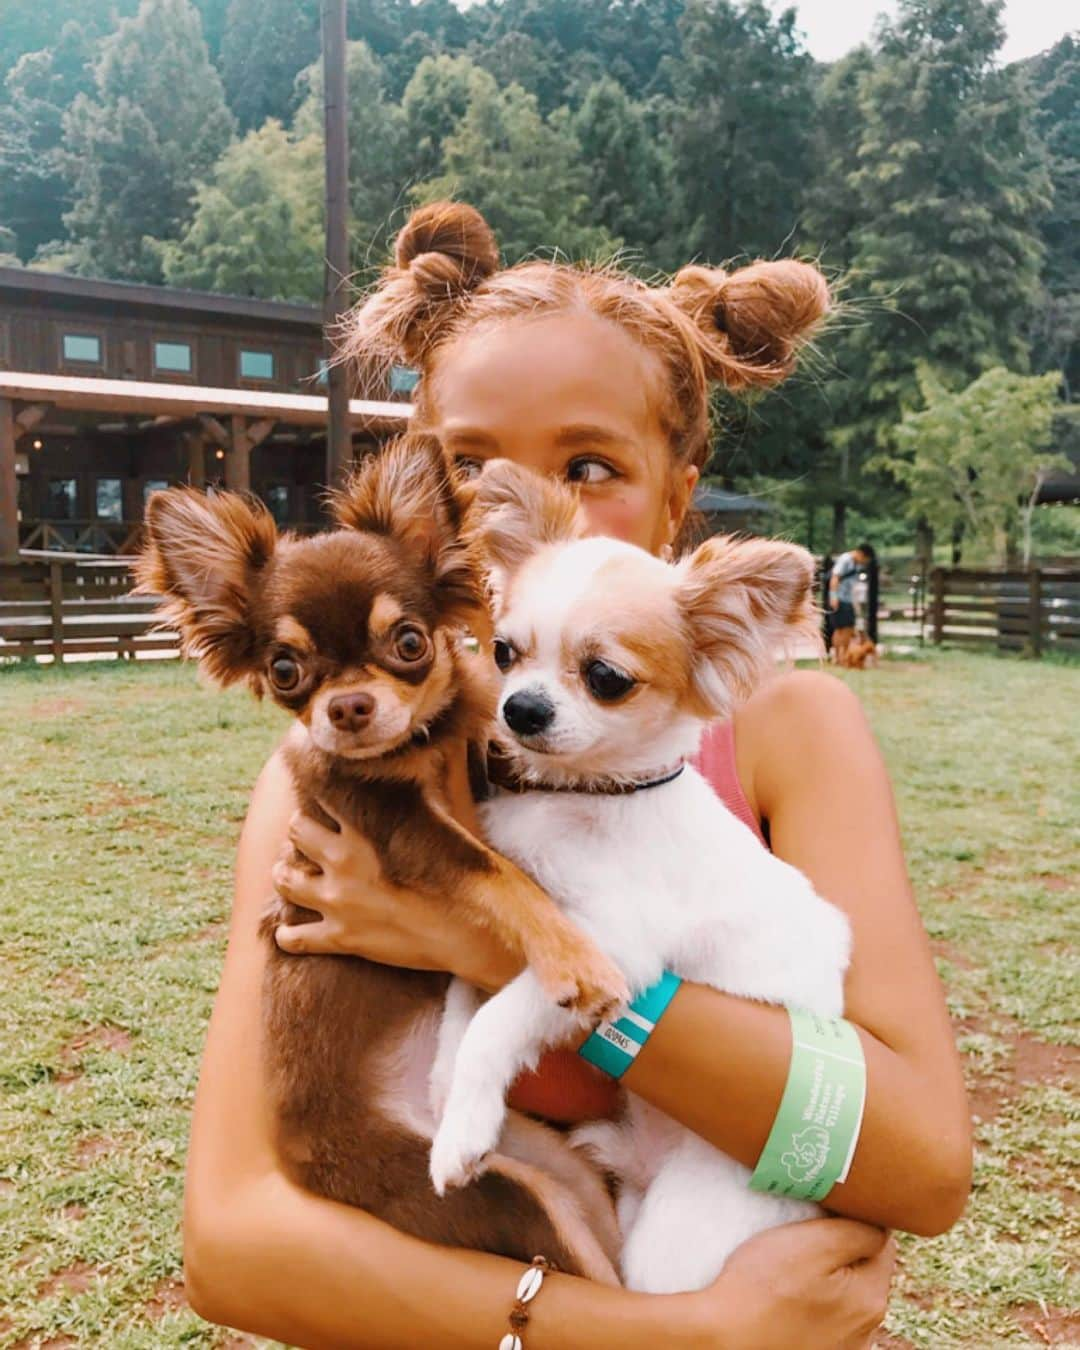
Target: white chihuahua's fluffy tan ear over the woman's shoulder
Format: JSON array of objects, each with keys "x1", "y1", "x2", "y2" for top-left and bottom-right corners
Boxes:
[{"x1": 676, "y1": 536, "x2": 821, "y2": 717}]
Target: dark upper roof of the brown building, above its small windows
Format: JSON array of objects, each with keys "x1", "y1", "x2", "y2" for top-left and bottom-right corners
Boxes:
[{"x1": 0, "y1": 267, "x2": 323, "y2": 331}]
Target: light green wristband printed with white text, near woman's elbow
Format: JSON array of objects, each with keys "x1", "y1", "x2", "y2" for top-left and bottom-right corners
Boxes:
[{"x1": 751, "y1": 1008, "x2": 867, "y2": 1200}]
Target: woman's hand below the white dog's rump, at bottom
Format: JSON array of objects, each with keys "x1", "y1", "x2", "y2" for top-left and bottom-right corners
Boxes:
[{"x1": 690, "y1": 1219, "x2": 896, "y2": 1350}]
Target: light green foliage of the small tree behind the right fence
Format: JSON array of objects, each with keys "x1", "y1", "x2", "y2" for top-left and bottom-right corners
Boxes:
[{"x1": 888, "y1": 366, "x2": 1069, "y2": 563}]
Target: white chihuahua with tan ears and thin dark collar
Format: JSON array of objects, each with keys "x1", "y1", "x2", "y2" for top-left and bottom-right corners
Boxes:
[{"x1": 431, "y1": 463, "x2": 849, "y2": 1293}]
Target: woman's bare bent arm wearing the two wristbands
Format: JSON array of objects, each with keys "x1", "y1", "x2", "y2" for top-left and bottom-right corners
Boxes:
[{"x1": 624, "y1": 672, "x2": 972, "y2": 1235}]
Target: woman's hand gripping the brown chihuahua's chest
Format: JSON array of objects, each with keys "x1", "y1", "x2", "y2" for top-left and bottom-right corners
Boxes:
[{"x1": 273, "y1": 806, "x2": 518, "y2": 990}]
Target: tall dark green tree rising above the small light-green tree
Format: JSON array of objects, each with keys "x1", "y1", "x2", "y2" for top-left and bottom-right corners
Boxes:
[{"x1": 842, "y1": 0, "x2": 1049, "y2": 448}]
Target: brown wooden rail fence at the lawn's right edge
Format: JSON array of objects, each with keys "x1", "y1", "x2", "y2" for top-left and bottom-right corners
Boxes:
[{"x1": 929, "y1": 567, "x2": 1080, "y2": 656}]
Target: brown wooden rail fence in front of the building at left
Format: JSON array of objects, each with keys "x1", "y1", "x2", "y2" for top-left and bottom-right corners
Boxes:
[{"x1": 0, "y1": 554, "x2": 172, "y2": 662}]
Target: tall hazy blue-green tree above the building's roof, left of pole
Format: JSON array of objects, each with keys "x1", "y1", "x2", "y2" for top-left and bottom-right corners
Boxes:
[{"x1": 65, "y1": 0, "x2": 232, "y2": 281}]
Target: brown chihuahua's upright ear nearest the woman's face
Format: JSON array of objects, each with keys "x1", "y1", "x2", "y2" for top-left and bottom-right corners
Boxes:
[{"x1": 331, "y1": 432, "x2": 486, "y2": 632}]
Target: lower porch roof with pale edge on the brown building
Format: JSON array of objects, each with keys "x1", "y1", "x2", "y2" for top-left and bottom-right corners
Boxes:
[{"x1": 0, "y1": 370, "x2": 413, "y2": 427}]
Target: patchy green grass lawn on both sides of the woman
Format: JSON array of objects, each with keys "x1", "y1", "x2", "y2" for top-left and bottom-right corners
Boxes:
[{"x1": 0, "y1": 653, "x2": 1080, "y2": 1350}]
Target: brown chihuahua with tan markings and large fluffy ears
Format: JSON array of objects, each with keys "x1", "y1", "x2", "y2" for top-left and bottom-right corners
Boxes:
[{"x1": 138, "y1": 435, "x2": 626, "y2": 1283}]
